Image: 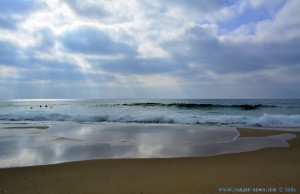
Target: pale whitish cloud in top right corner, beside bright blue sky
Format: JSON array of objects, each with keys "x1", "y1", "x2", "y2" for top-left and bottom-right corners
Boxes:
[{"x1": 219, "y1": 0, "x2": 300, "y2": 43}]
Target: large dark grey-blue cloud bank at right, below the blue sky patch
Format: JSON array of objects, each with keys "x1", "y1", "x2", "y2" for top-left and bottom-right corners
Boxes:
[{"x1": 163, "y1": 26, "x2": 300, "y2": 74}]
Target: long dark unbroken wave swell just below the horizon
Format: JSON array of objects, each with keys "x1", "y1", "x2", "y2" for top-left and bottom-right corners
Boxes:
[{"x1": 122, "y1": 103, "x2": 276, "y2": 110}]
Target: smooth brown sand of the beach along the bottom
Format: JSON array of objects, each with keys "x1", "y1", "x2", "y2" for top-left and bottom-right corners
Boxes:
[{"x1": 0, "y1": 129, "x2": 300, "y2": 194}]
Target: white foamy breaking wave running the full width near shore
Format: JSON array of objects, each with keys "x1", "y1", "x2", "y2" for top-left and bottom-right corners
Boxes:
[{"x1": 0, "y1": 113, "x2": 300, "y2": 127}]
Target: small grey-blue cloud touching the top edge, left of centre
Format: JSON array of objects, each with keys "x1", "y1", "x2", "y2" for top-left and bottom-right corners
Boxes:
[{"x1": 64, "y1": 0, "x2": 110, "y2": 19}]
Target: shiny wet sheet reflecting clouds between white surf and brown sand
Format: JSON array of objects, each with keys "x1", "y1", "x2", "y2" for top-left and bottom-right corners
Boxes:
[{"x1": 0, "y1": 124, "x2": 295, "y2": 168}]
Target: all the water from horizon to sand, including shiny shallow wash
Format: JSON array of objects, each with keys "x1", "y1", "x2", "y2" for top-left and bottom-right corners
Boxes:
[{"x1": 0, "y1": 99, "x2": 300, "y2": 168}]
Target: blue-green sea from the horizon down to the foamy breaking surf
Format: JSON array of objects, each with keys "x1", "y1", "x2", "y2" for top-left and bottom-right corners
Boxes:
[{"x1": 0, "y1": 99, "x2": 300, "y2": 127}]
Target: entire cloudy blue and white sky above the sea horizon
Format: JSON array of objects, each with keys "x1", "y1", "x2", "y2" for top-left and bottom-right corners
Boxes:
[{"x1": 0, "y1": 0, "x2": 300, "y2": 99}]
